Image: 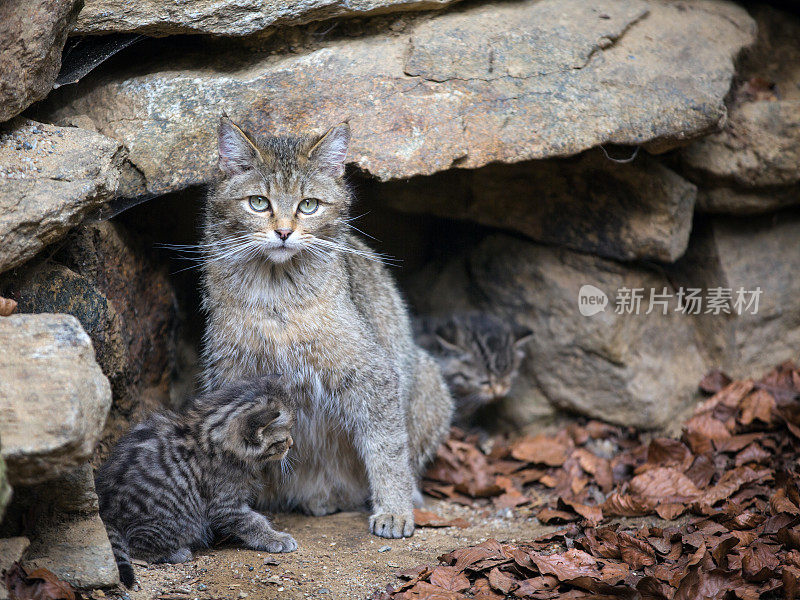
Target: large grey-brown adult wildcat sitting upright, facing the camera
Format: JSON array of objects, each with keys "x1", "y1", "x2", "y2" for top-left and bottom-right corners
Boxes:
[{"x1": 201, "y1": 118, "x2": 452, "y2": 537}]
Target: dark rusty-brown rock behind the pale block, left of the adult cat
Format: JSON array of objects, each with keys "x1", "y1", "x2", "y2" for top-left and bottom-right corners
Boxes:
[{"x1": 6, "y1": 222, "x2": 176, "y2": 461}]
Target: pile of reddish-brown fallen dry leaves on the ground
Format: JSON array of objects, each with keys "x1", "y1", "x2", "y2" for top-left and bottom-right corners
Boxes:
[{"x1": 375, "y1": 363, "x2": 800, "y2": 600}]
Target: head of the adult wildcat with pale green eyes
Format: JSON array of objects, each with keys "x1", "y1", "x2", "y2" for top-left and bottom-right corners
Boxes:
[{"x1": 207, "y1": 118, "x2": 351, "y2": 263}]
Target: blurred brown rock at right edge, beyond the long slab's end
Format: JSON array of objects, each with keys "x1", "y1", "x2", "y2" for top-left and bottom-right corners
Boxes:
[{"x1": 681, "y1": 6, "x2": 800, "y2": 214}]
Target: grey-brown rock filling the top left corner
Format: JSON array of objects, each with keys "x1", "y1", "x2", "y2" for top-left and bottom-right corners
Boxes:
[{"x1": 0, "y1": 0, "x2": 80, "y2": 123}]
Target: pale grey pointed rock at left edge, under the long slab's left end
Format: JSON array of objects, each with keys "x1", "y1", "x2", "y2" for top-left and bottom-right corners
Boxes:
[{"x1": 0, "y1": 118, "x2": 123, "y2": 272}]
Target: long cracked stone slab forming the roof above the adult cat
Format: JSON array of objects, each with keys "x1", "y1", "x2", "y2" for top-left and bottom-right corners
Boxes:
[{"x1": 43, "y1": 0, "x2": 754, "y2": 195}]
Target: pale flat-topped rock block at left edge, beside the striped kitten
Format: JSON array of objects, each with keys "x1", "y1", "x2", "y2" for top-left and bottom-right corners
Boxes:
[{"x1": 0, "y1": 314, "x2": 111, "y2": 486}]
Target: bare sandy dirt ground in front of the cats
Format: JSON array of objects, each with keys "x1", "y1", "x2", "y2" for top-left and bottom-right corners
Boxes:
[{"x1": 91, "y1": 499, "x2": 556, "y2": 600}]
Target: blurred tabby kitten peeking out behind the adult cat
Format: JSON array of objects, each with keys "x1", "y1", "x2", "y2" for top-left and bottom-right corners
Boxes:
[{"x1": 414, "y1": 312, "x2": 532, "y2": 425}]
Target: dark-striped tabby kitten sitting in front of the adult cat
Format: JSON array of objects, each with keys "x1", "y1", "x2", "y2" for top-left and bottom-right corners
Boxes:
[{"x1": 95, "y1": 376, "x2": 297, "y2": 587}]
